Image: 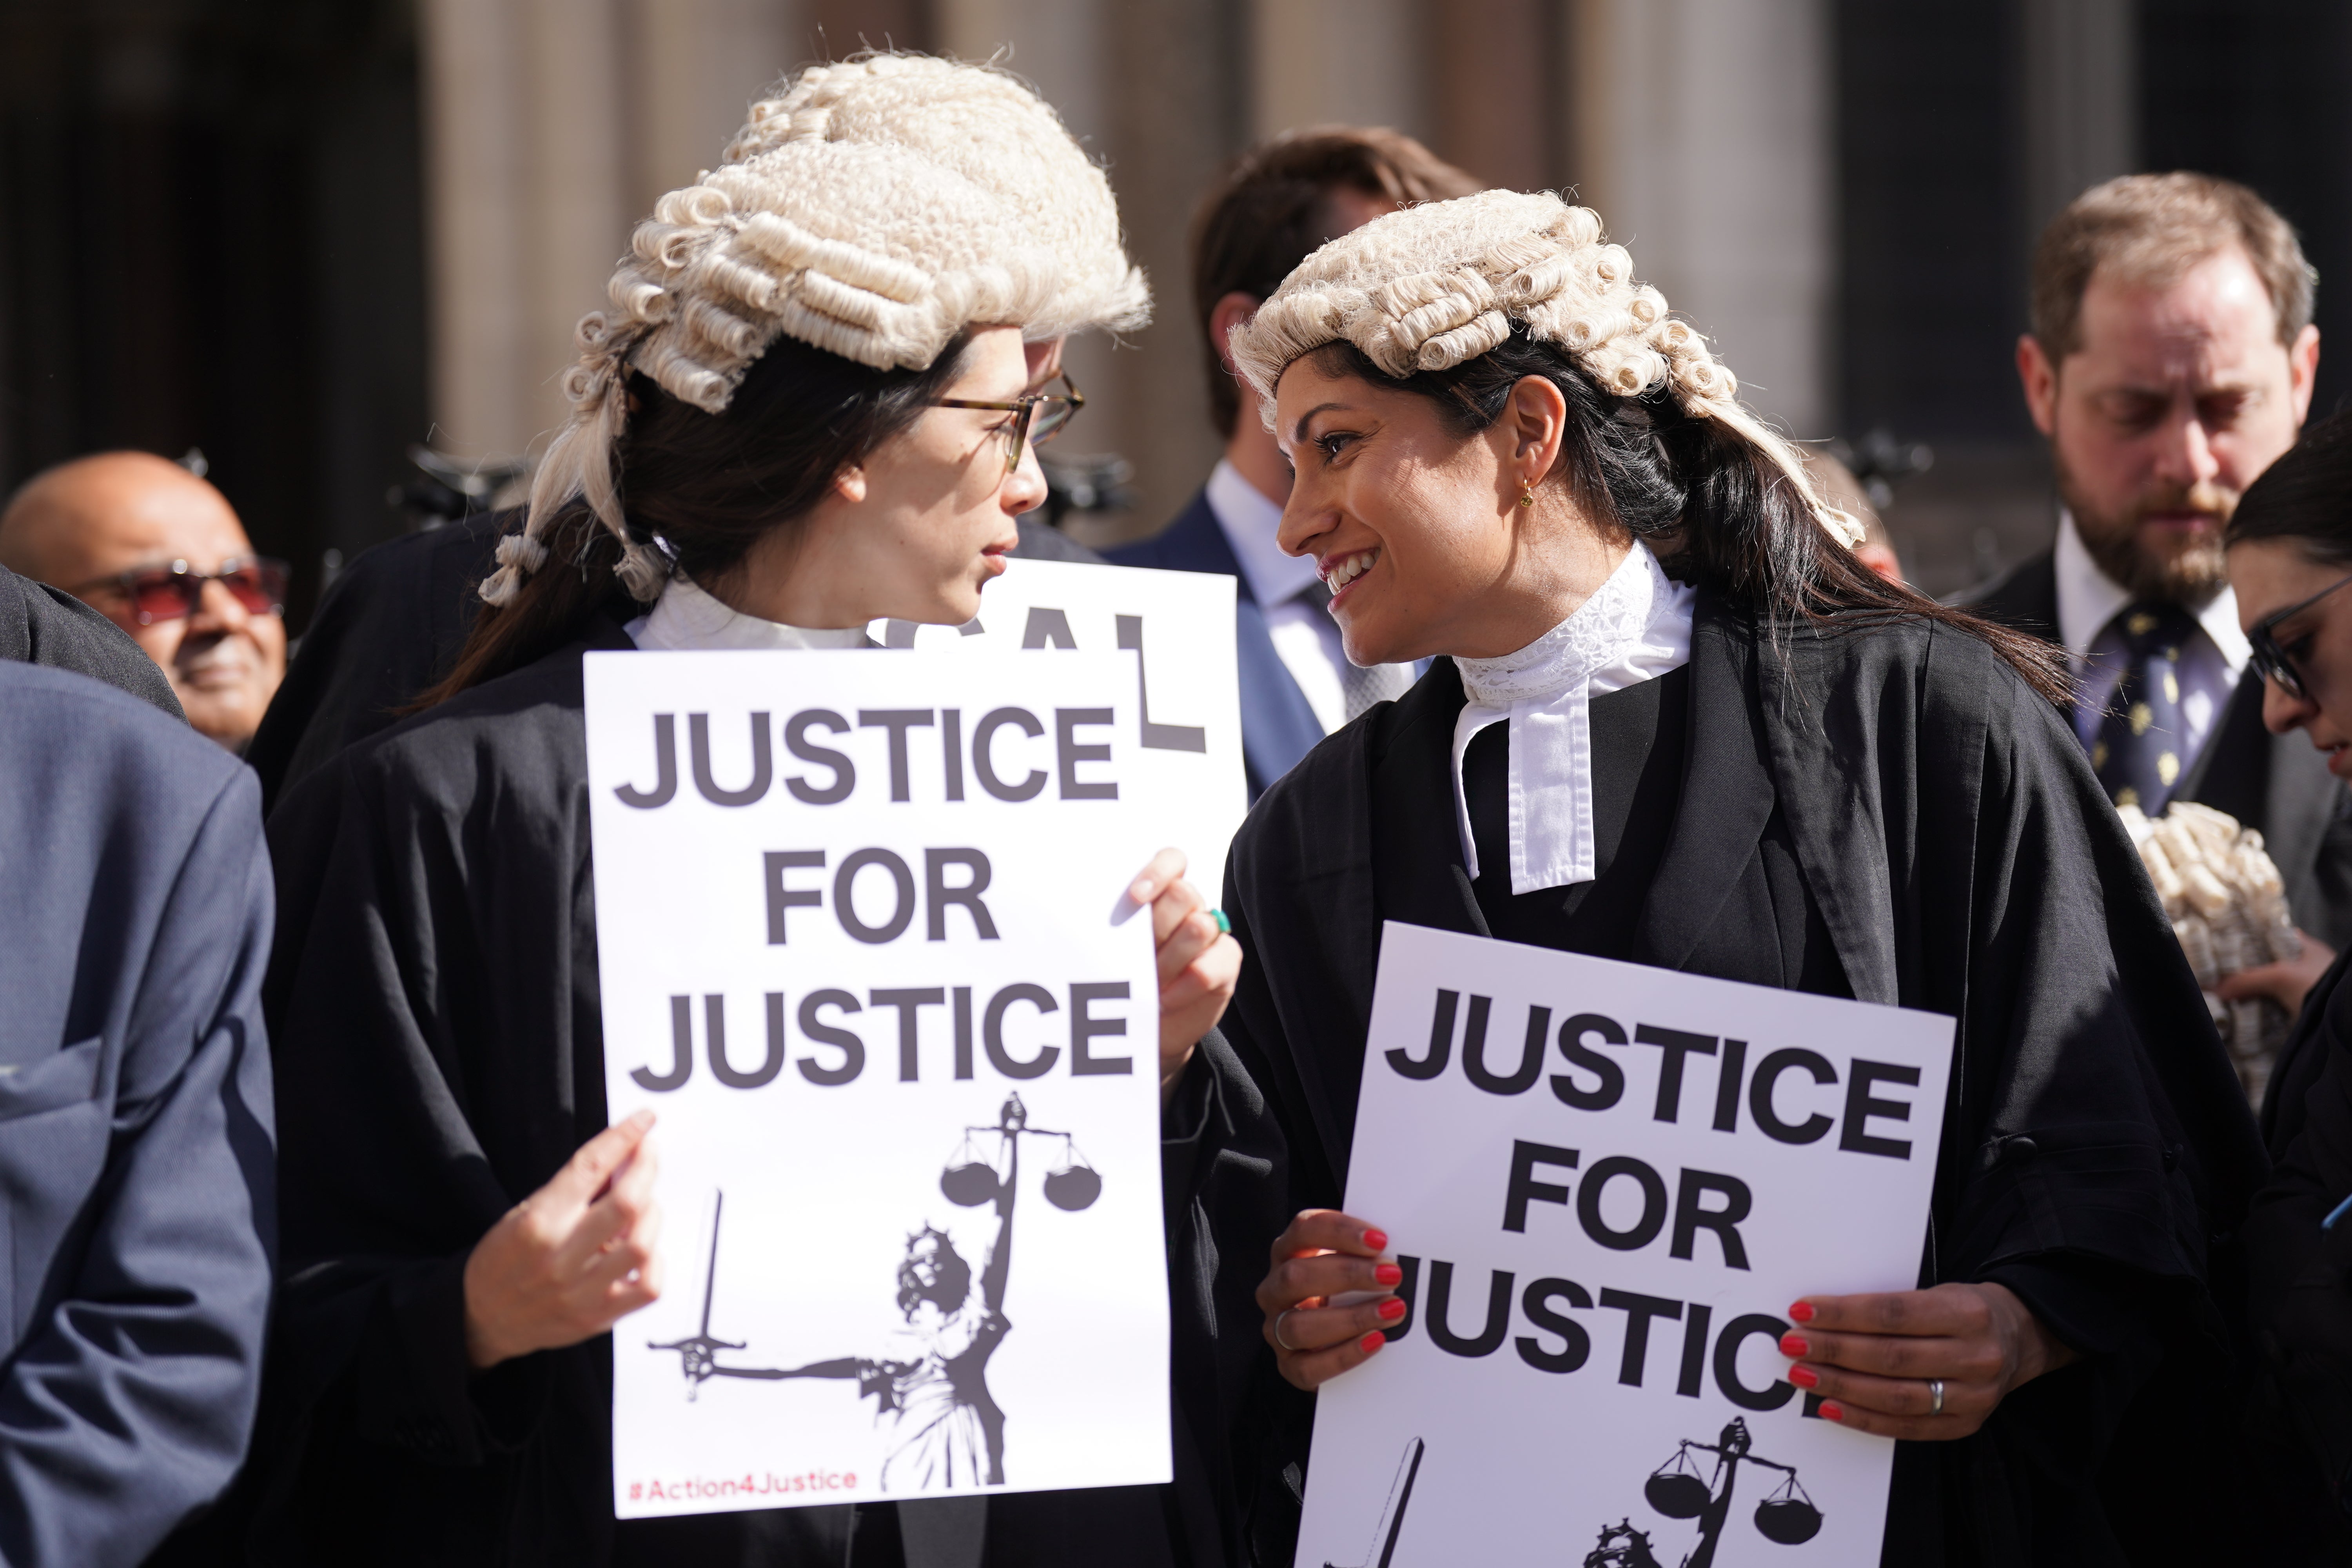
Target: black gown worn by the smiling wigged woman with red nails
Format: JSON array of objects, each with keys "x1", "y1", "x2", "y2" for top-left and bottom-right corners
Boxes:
[{"x1": 1190, "y1": 592, "x2": 2263, "y2": 1568}]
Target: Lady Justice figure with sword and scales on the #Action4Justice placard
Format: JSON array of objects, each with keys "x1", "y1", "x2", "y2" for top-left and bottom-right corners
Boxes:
[{"x1": 647, "y1": 1093, "x2": 1103, "y2": 1490}]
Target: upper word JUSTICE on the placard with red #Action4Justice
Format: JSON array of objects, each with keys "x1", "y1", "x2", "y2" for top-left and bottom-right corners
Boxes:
[{"x1": 614, "y1": 708, "x2": 1120, "y2": 811}]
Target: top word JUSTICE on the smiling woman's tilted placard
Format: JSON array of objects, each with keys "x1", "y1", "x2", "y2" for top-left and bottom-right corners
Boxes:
[{"x1": 1388, "y1": 990, "x2": 1919, "y2": 1159}]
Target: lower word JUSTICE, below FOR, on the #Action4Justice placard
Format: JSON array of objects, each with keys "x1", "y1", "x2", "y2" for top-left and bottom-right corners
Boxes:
[{"x1": 628, "y1": 980, "x2": 1136, "y2": 1093}]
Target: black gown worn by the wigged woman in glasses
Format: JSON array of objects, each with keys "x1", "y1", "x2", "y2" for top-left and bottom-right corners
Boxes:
[{"x1": 247, "y1": 618, "x2": 1230, "y2": 1568}]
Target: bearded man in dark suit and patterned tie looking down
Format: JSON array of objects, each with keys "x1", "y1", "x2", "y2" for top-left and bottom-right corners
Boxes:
[{"x1": 1973, "y1": 174, "x2": 2352, "y2": 1011}]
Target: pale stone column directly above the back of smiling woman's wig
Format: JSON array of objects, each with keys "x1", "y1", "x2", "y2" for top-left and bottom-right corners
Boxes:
[{"x1": 1571, "y1": 0, "x2": 1837, "y2": 437}]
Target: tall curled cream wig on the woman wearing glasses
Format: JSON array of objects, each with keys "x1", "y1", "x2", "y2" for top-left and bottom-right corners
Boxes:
[{"x1": 482, "y1": 54, "x2": 1150, "y2": 604}]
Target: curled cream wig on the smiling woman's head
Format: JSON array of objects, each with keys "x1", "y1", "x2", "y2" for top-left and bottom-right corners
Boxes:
[{"x1": 1232, "y1": 191, "x2": 1863, "y2": 548}]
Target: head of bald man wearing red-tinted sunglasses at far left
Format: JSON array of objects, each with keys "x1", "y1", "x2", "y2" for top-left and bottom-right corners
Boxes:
[{"x1": 0, "y1": 451, "x2": 287, "y2": 752}]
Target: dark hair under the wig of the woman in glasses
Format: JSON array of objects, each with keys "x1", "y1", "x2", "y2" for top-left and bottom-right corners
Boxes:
[{"x1": 416, "y1": 334, "x2": 969, "y2": 708}]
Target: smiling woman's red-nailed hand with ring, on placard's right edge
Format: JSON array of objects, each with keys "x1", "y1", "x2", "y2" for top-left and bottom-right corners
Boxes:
[{"x1": 1780, "y1": 1283, "x2": 2074, "y2": 1443}]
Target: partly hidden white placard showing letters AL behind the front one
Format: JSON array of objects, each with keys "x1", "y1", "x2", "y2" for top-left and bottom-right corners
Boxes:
[{"x1": 875, "y1": 557, "x2": 1249, "y2": 903}]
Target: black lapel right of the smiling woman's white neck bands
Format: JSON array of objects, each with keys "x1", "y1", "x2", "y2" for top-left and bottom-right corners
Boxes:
[{"x1": 1635, "y1": 592, "x2": 1773, "y2": 969}]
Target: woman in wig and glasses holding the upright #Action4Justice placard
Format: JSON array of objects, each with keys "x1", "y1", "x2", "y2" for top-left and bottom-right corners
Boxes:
[{"x1": 256, "y1": 54, "x2": 1240, "y2": 1568}]
